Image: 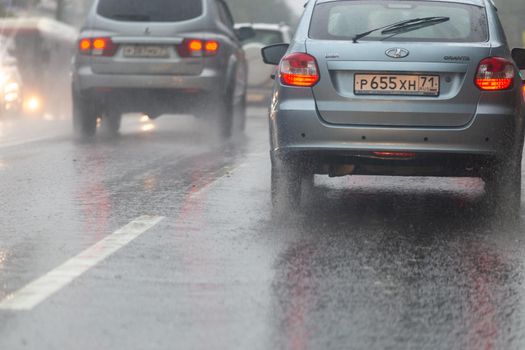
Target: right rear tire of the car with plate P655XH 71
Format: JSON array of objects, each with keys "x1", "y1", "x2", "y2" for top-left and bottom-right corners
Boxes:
[{"x1": 484, "y1": 159, "x2": 521, "y2": 221}]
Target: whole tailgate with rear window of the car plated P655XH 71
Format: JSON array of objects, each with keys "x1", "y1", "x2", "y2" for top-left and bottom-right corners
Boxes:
[{"x1": 306, "y1": 0, "x2": 490, "y2": 127}]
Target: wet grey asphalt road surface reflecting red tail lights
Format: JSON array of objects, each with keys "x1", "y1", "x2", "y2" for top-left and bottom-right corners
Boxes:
[{"x1": 0, "y1": 109, "x2": 525, "y2": 350}]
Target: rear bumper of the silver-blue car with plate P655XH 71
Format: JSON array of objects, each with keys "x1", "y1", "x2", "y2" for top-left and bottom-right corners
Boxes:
[{"x1": 270, "y1": 93, "x2": 523, "y2": 176}]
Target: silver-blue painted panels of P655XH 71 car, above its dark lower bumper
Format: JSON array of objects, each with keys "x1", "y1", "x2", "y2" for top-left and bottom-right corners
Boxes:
[{"x1": 269, "y1": 0, "x2": 524, "y2": 170}]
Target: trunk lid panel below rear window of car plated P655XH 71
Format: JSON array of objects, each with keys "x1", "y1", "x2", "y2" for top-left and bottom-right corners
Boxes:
[{"x1": 306, "y1": 39, "x2": 490, "y2": 127}]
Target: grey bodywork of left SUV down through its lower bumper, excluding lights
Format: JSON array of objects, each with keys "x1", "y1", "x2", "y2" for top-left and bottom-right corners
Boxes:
[{"x1": 73, "y1": 0, "x2": 247, "y2": 137}]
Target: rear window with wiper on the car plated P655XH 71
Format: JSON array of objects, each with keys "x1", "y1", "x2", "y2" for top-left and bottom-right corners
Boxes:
[{"x1": 310, "y1": 0, "x2": 488, "y2": 42}]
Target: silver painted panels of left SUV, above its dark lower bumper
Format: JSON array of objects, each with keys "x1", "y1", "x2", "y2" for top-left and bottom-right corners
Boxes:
[{"x1": 73, "y1": 0, "x2": 247, "y2": 97}]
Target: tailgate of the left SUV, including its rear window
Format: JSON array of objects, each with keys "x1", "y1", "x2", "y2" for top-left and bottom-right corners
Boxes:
[{"x1": 87, "y1": 0, "x2": 207, "y2": 75}]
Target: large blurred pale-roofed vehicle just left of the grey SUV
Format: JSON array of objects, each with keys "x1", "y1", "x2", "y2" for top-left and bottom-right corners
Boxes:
[{"x1": 0, "y1": 18, "x2": 78, "y2": 118}]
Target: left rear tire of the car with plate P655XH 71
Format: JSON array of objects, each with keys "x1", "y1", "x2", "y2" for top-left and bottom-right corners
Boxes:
[{"x1": 271, "y1": 160, "x2": 303, "y2": 215}]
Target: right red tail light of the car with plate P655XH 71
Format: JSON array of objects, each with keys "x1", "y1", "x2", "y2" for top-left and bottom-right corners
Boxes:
[{"x1": 476, "y1": 57, "x2": 516, "y2": 91}]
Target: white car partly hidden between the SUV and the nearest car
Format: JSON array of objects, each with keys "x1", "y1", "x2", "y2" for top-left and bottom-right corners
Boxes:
[{"x1": 236, "y1": 23, "x2": 292, "y2": 103}]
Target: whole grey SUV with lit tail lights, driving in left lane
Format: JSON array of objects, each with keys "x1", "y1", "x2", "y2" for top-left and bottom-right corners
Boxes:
[{"x1": 73, "y1": 0, "x2": 253, "y2": 137}]
